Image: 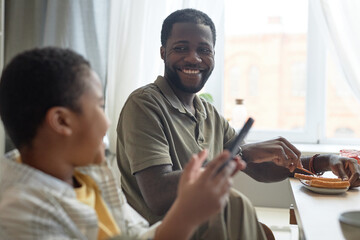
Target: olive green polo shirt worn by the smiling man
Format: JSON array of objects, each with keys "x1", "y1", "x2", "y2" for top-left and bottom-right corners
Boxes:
[{"x1": 117, "y1": 76, "x2": 236, "y2": 224}]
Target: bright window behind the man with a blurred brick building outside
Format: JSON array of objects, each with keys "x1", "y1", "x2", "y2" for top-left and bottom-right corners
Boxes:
[{"x1": 223, "y1": 0, "x2": 360, "y2": 144}]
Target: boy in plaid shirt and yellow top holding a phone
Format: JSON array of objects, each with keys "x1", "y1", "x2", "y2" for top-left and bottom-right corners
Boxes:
[{"x1": 0, "y1": 47, "x2": 245, "y2": 239}]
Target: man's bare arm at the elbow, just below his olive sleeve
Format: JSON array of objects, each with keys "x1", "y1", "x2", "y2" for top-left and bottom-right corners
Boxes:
[{"x1": 135, "y1": 164, "x2": 182, "y2": 216}]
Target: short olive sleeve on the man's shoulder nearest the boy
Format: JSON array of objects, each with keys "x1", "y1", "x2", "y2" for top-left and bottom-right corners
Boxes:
[{"x1": 117, "y1": 93, "x2": 172, "y2": 174}]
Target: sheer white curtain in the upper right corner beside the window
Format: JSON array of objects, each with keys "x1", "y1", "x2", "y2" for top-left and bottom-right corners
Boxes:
[{"x1": 309, "y1": 0, "x2": 360, "y2": 101}]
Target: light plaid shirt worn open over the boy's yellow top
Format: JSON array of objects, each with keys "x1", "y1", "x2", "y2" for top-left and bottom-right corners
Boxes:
[{"x1": 0, "y1": 150, "x2": 158, "y2": 240}]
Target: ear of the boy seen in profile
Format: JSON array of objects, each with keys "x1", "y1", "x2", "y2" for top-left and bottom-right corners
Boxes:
[{"x1": 45, "y1": 107, "x2": 73, "y2": 136}]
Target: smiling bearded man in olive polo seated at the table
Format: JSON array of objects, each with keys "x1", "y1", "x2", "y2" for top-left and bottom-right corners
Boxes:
[{"x1": 117, "y1": 9, "x2": 360, "y2": 240}]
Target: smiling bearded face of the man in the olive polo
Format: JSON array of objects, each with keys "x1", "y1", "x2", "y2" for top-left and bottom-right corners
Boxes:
[{"x1": 161, "y1": 22, "x2": 215, "y2": 97}]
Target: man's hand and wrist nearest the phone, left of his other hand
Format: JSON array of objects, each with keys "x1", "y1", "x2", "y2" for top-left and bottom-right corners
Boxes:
[{"x1": 241, "y1": 137, "x2": 302, "y2": 172}]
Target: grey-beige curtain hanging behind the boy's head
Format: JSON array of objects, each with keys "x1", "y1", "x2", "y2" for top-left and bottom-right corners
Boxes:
[{"x1": 4, "y1": 0, "x2": 110, "y2": 151}]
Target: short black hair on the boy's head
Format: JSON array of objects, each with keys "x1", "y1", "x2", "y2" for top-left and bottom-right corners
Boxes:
[{"x1": 0, "y1": 47, "x2": 90, "y2": 148}]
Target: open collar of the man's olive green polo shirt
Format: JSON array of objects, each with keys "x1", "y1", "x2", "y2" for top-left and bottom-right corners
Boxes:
[{"x1": 155, "y1": 76, "x2": 207, "y2": 119}]
